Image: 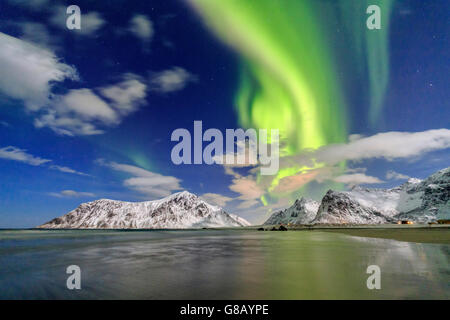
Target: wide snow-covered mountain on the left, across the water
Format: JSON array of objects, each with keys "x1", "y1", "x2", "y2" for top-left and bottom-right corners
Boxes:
[{"x1": 38, "y1": 191, "x2": 250, "y2": 229}]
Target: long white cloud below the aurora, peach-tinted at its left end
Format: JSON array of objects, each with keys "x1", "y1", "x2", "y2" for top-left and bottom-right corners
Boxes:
[{"x1": 221, "y1": 129, "x2": 450, "y2": 210}]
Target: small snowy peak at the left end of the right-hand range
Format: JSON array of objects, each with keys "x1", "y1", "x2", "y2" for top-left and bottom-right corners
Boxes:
[{"x1": 264, "y1": 197, "x2": 320, "y2": 225}]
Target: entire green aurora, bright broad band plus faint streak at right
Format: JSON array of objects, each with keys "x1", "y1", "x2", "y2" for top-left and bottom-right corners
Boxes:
[{"x1": 190, "y1": 0, "x2": 392, "y2": 201}]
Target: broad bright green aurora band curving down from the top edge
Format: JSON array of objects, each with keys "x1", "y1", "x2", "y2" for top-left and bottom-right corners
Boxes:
[{"x1": 188, "y1": 0, "x2": 346, "y2": 154}]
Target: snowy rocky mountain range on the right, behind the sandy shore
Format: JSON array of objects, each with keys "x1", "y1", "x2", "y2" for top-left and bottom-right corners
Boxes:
[{"x1": 265, "y1": 168, "x2": 450, "y2": 224}]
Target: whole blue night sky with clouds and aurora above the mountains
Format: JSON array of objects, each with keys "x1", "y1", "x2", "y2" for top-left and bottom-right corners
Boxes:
[{"x1": 0, "y1": 0, "x2": 450, "y2": 228}]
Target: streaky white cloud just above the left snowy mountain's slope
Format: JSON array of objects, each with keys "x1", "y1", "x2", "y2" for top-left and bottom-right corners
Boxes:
[{"x1": 96, "y1": 159, "x2": 182, "y2": 198}]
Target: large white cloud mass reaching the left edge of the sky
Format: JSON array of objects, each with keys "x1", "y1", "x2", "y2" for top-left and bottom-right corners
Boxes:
[{"x1": 0, "y1": 33, "x2": 147, "y2": 136}]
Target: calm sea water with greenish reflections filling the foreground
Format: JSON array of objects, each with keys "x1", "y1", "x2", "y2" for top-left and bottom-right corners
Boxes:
[{"x1": 0, "y1": 230, "x2": 450, "y2": 299}]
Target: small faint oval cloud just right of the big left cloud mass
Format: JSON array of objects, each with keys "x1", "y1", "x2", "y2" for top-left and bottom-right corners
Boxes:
[{"x1": 150, "y1": 67, "x2": 197, "y2": 93}]
